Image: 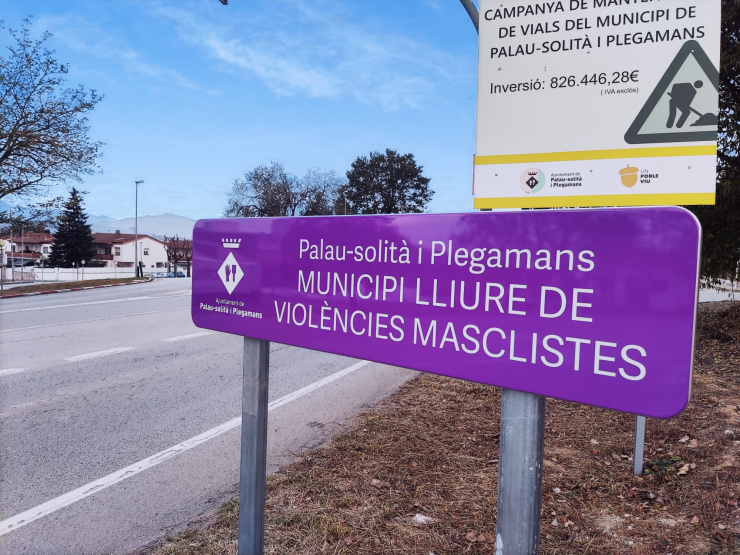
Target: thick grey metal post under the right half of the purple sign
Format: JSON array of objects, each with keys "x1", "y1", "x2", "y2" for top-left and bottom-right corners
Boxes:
[{"x1": 496, "y1": 389, "x2": 545, "y2": 555}]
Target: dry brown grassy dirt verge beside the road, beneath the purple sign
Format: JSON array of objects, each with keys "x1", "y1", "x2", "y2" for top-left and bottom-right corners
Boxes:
[{"x1": 145, "y1": 303, "x2": 740, "y2": 555}]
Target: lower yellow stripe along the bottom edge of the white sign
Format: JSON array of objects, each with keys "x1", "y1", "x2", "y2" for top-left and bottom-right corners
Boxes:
[{"x1": 473, "y1": 193, "x2": 715, "y2": 209}]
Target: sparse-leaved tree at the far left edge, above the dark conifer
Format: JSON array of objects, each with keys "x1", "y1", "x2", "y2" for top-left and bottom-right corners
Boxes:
[{"x1": 0, "y1": 19, "x2": 103, "y2": 222}]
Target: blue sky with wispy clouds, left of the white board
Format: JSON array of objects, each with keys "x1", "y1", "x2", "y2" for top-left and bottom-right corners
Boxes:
[{"x1": 0, "y1": 0, "x2": 477, "y2": 222}]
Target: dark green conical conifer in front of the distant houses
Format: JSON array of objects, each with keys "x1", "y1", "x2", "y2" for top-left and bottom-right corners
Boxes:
[{"x1": 49, "y1": 187, "x2": 95, "y2": 268}]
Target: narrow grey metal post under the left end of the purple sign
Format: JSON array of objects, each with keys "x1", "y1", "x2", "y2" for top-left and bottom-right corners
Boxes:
[{"x1": 238, "y1": 337, "x2": 270, "y2": 555}]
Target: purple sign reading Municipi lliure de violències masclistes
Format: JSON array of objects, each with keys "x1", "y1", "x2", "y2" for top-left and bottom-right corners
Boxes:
[{"x1": 192, "y1": 207, "x2": 701, "y2": 418}]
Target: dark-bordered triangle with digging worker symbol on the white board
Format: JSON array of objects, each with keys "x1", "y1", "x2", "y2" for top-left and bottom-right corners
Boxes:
[{"x1": 624, "y1": 40, "x2": 719, "y2": 144}]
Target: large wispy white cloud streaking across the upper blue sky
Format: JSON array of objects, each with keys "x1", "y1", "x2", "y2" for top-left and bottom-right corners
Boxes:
[{"x1": 152, "y1": 0, "x2": 465, "y2": 110}]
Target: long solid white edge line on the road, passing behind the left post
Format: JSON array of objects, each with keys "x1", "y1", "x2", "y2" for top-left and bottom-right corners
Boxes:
[{"x1": 0, "y1": 360, "x2": 370, "y2": 536}]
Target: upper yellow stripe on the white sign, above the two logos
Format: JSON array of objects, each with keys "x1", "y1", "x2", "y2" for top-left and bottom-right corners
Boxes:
[{"x1": 475, "y1": 144, "x2": 717, "y2": 166}]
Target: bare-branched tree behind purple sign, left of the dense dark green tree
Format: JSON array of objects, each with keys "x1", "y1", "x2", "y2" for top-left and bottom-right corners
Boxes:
[{"x1": 224, "y1": 162, "x2": 342, "y2": 218}]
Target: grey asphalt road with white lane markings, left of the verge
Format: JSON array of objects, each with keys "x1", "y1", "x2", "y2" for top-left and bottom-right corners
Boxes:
[{"x1": 0, "y1": 279, "x2": 414, "y2": 555}]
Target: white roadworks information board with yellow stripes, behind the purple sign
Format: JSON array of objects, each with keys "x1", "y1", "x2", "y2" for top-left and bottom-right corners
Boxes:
[{"x1": 473, "y1": 0, "x2": 721, "y2": 208}]
